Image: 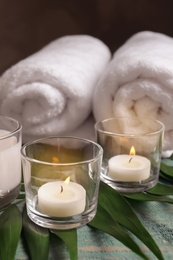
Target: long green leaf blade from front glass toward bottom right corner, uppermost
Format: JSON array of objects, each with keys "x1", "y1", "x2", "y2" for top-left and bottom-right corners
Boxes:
[{"x1": 98, "y1": 182, "x2": 163, "y2": 259}]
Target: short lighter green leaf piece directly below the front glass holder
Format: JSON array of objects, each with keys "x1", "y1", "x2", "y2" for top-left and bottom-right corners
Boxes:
[{"x1": 51, "y1": 229, "x2": 78, "y2": 260}]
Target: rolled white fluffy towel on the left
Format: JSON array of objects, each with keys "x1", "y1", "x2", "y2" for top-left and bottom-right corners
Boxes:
[{"x1": 0, "y1": 35, "x2": 111, "y2": 142}]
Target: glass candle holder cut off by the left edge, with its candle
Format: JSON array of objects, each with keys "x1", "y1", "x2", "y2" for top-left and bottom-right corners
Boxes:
[{"x1": 0, "y1": 116, "x2": 22, "y2": 210}]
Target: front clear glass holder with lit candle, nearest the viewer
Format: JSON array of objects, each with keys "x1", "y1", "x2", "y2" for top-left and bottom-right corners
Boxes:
[{"x1": 21, "y1": 137, "x2": 103, "y2": 230}]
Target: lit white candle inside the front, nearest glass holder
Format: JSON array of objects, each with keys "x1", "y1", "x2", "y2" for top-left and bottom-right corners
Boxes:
[{"x1": 38, "y1": 181, "x2": 86, "y2": 217}]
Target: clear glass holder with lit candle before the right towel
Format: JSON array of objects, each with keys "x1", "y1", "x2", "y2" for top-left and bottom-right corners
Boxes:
[{"x1": 95, "y1": 117, "x2": 164, "y2": 193}]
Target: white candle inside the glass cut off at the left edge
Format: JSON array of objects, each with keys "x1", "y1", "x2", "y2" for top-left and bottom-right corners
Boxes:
[{"x1": 0, "y1": 130, "x2": 21, "y2": 193}]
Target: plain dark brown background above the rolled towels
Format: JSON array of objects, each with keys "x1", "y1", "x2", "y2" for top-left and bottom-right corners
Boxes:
[{"x1": 0, "y1": 0, "x2": 173, "y2": 74}]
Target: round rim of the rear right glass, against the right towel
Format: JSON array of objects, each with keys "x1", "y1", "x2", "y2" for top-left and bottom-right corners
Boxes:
[{"x1": 94, "y1": 117, "x2": 165, "y2": 138}]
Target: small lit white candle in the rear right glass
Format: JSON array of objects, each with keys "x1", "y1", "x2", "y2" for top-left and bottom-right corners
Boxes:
[{"x1": 108, "y1": 154, "x2": 151, "y2": 181}]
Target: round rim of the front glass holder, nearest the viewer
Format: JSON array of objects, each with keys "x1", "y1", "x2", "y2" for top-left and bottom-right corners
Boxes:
[{"x1": 21, "y1": 136, "x2": 103, "y2": 166}]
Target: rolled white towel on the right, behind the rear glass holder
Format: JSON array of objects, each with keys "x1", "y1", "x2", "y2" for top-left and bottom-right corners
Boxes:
[{"x1": 93, "y1": 31, "x2": 173, "y2": 150}]
